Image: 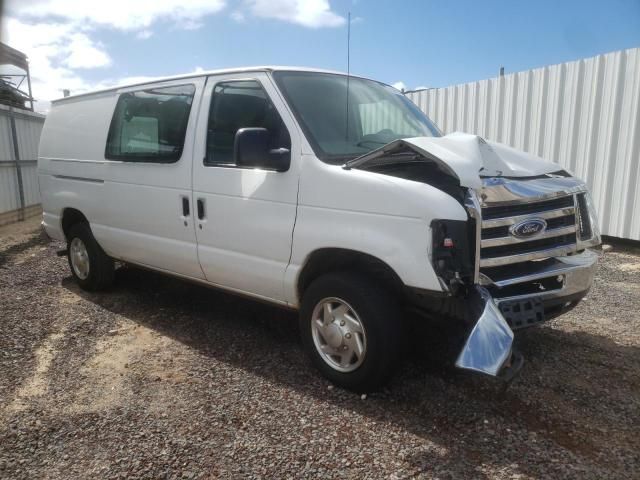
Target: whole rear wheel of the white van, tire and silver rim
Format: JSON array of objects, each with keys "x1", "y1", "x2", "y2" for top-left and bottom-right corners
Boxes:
[{"x1": 67, "y1": 223, "x2": 115, "y2": 291}]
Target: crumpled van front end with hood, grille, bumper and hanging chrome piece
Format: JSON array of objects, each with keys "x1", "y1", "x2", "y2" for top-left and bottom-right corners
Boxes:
[{"x1": 344, "y1": 134, "x2": 600, "y2": 381}]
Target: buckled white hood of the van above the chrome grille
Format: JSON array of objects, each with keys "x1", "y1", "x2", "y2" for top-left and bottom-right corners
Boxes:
[{"x1": 347, "y1": 132, "x2": 561, "y2": 188}]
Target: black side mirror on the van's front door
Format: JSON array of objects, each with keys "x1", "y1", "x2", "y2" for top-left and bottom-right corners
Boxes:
[{"x1": 233, "y1": 128, "x2": 291, "y2": 172}]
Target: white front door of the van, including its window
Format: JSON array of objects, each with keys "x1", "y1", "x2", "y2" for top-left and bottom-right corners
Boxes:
[{"x1": 193, "y1": 73, "x2": 301, "y2": 302}]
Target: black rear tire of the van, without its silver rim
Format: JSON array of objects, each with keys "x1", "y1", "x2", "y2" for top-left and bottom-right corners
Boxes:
[{"x1": 67, "y1": 223, "x2": 115, "y2": 292}]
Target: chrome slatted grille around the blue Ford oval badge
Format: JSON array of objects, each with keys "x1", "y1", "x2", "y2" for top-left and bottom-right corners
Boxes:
[{"x1": 480, "y1": 194, "x2": 580, "y2": 268}]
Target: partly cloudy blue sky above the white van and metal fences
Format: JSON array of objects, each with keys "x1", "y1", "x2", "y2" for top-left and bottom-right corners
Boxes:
[{"x1": 2, "y1": 0, "x2": 640, "y2": 110}]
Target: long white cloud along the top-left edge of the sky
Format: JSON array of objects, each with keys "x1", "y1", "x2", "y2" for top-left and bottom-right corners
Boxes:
[{"x1": 8, "y1": 0, "x2": 226, "y2": 30}]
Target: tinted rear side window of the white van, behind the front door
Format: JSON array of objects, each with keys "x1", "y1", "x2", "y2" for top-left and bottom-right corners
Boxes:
[{"x1": 105, "y1": 85, "x2": 196, "y2": 163}]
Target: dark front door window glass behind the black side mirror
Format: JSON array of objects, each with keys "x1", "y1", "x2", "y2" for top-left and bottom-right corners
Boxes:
[{"x1": 204, "y1": 80, "x2": 291, "y2": 166}]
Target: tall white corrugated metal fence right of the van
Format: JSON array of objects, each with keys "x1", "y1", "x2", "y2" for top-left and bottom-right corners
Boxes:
[{"x1": 407, "y1": 48, "x2": 640, "y2": 240}]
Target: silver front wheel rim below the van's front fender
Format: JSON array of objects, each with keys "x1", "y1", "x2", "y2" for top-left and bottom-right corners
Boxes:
[{"x1": 311, "y1": 297, "x2": 367, "y2": 373}]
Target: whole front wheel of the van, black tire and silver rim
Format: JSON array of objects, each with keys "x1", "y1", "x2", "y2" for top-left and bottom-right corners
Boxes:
[{"x1": 300, "y1": 272, "x2": 404, "y2": 392}]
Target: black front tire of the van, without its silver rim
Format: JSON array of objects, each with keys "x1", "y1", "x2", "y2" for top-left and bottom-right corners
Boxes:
[{"x1": 299, "y1": 272, "x2": 404, "y2": 393}]
